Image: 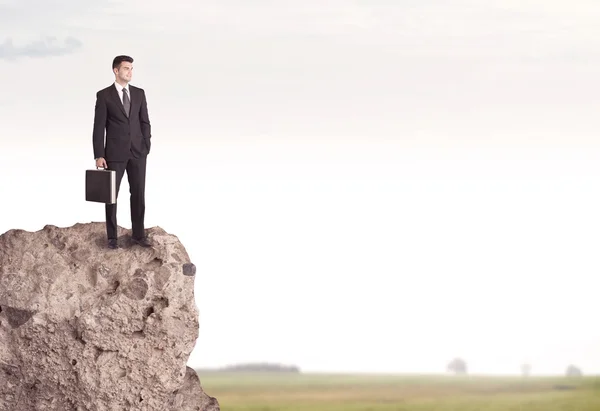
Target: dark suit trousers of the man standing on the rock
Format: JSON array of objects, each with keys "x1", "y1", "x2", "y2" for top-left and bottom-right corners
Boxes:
[{"x1": 106, "y1": 155, "x2": 146, "y2": 243}]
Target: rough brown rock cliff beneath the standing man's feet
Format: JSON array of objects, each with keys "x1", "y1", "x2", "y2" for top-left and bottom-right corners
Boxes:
[{"x1": 0, "y1": 223, "x2": 219, "y2": 411}]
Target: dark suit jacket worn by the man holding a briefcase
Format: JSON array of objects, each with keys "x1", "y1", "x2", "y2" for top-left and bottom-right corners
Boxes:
[{"x1": 92, "y1": 83, "x2": 151, "y2": 161}]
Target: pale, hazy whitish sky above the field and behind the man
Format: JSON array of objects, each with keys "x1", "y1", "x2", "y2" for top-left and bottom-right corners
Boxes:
[{"x1": 0, "y1": 0, "x2": 600, "y2": 375}]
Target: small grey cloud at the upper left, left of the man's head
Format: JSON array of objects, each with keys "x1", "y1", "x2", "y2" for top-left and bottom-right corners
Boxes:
[{"x1": 0, "y1": 36, "x2": 82, "y2": 60}]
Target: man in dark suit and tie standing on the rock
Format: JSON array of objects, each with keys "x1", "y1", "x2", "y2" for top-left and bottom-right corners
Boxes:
[{"x1": 92, "y1": 56, "x2": 151, "y2": 249}]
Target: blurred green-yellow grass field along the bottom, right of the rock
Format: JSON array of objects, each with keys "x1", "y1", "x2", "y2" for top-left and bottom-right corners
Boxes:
[{"x1": 199, "y1": 372, "x2": 600, "y2": 411}]
